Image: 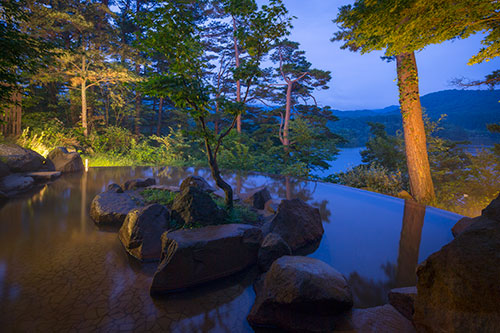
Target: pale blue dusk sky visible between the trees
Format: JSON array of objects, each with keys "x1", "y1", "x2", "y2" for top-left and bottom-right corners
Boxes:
[{"x1": 276, "y1": 0, "x2": 500, "y2": 110}]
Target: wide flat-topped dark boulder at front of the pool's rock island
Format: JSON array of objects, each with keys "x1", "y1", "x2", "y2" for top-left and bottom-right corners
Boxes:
[{"x1": 151, "y1": 224, "x2": 262, "y2": 294}]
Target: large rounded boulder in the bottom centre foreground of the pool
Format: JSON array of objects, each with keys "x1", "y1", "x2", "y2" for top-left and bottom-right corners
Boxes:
[{"x1": 247, "y1": 256, "x2": 353, "y2": 332}]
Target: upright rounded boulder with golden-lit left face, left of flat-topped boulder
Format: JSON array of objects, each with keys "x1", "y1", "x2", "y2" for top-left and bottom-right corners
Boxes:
[{"x1": 118, "y1": 204, "x2": 170, "y2": 261}]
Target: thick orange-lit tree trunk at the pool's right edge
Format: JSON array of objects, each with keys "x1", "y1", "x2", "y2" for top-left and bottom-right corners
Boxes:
[{"x1": 396, "y1": 52, "x2": 435, "y2": 204}]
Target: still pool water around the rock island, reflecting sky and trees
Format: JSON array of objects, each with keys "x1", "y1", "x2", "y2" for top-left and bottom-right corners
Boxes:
[{"x1": 0, "y1": 168, "x2": 459, "y2": 332}]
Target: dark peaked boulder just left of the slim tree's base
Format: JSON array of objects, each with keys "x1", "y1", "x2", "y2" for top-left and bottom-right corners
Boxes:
[{"x1": 172, "y1": 186, "x2": 225, "y2": 226}]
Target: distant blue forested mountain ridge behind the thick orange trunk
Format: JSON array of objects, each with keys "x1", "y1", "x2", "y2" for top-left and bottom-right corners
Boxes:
[{"x1": 329, "y1": 90, "x2": 500, "y2": 147}]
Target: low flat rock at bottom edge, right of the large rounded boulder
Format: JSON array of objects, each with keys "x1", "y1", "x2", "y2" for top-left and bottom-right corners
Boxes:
[{"x1": 335, "y1": 304, "x2": 416, "y2": 333}]
